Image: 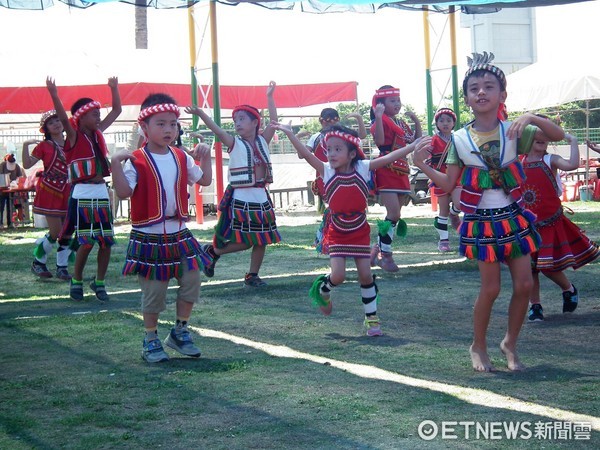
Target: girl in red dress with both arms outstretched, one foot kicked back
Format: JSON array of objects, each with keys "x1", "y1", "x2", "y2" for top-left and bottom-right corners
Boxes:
[{"x1": 278, "y1": 121, "x2": 430, "y2": 336}]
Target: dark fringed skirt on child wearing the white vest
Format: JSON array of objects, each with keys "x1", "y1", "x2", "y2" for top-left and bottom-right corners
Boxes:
[{"x1": 213, "y1": 188, "x2": 281, "y2": 248}]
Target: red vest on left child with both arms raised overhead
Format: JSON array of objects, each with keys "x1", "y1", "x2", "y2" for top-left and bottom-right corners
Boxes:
[{"x1": 65, "y1": 130, "x2": 110, "y2": 183}]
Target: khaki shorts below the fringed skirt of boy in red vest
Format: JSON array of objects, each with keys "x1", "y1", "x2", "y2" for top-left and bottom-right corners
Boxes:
[{"x1": 138, "y1": 260, "x2": 200, "y2": 313}]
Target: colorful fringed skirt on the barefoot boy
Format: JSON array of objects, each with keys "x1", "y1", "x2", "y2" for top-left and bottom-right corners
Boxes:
[{"x1": 459, "y1": 203, "x2": 540, "y2": 263}]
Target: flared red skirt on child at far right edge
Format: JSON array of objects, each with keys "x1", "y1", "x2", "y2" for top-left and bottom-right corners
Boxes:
[{"x1": 532, "y1": 207, "x2": 600, "y2": 272}]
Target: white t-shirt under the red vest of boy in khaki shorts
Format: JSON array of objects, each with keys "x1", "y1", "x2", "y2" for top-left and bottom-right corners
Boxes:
[{"x1": 123, "y1": 152, "x2": 202, "y2": 234}]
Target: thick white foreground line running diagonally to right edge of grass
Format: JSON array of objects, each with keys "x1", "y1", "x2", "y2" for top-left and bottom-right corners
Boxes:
[{"x1": 190, "y1": 327, "x2": 600, "y2": 431}]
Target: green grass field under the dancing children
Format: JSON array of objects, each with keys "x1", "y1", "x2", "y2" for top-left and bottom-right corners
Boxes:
[{"x1": 0, "y1": 202, "x2": 600, "y2": 449}]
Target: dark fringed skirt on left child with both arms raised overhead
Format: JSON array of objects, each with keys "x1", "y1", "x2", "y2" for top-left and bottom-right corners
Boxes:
[{"x1": 60, "y1": 198, "x2": 115, "y2": 248}]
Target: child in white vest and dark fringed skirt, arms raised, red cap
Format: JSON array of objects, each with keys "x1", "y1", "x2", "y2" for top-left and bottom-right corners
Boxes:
[{"x1": 185, "y1": 81, "x2": 281, "y2": 287}]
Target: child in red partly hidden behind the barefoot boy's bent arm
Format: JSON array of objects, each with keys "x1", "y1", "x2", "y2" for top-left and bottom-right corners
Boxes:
[{"x1": 428, "y1": 108, "x2": 460, "y2": 252}]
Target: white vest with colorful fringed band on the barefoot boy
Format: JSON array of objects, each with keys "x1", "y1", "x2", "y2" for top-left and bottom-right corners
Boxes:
[{"x1": 452, "y1": 122, "x2": 525, "y2": 213}]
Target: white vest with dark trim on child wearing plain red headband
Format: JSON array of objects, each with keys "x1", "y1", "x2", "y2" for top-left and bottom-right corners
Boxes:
[{"x1": 229, "y1": 136, "x2": 273, "y2": 188}]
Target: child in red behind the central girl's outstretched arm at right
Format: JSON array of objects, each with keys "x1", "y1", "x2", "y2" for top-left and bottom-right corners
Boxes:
[{"x1": 371, "y1": 85, "x2": 421, "y2": 272}]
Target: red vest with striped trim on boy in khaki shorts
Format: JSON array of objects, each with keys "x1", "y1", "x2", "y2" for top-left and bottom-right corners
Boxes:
[{"x1": 131, "y1": 147, "x2": 188, "y2": 227}]
